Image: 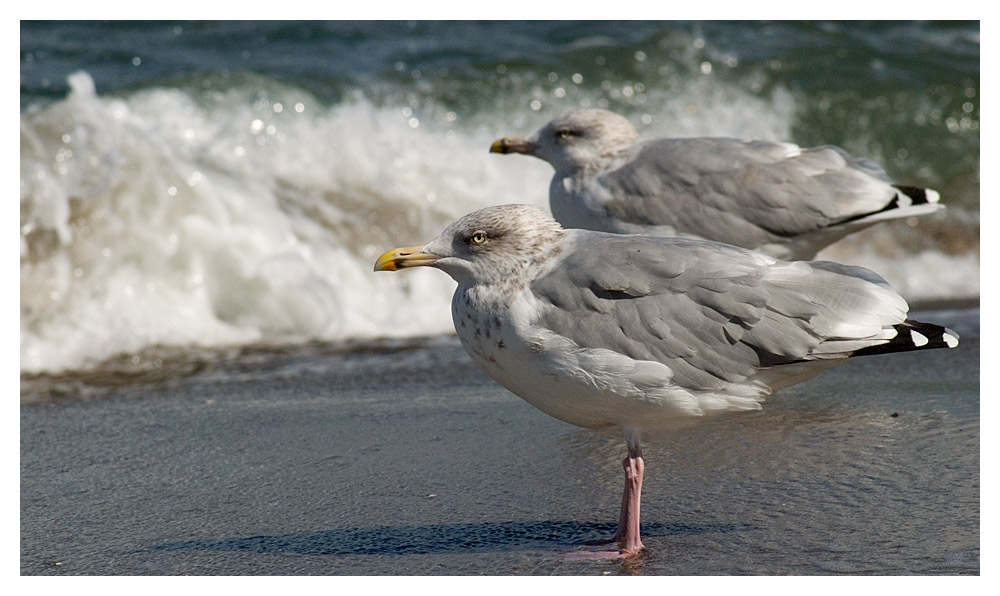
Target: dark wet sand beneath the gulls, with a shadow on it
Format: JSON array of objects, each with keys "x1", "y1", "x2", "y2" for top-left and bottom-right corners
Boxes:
[{"x1": 20, "y1": 311, "x2": 980, "y2": 576}]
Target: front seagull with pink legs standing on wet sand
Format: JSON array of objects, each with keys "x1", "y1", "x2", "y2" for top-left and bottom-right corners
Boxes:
[{"x1": 375, "y1": 205, "x2": 958, "y2": 556}]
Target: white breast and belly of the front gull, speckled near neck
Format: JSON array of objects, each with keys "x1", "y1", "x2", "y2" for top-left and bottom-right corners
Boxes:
[{"x1": 453, "y1": 292, "x2": 766, "y2": 429}]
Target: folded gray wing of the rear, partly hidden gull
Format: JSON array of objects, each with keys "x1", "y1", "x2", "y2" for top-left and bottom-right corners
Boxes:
[{"x1": 601, "y1": 138, "x2": 896, "y2": 246}]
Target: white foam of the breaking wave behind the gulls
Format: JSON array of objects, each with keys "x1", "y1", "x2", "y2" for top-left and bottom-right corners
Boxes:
[{"x1": 20, "y1": 73, "x2": 979, "y2": 372}]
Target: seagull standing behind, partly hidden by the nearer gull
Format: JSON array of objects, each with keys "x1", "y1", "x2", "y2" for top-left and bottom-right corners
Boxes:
[{"x1": 490, "y1": 110, "x2": 942, "y2": 260}]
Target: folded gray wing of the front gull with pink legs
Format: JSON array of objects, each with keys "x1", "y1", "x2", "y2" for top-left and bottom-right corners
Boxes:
[{"x1": 531, "y1": 230, "x2": 906, "y2": 390}]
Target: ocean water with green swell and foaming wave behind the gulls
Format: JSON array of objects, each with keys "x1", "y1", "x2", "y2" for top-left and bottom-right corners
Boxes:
[{"x1": 20, "y1": 21, "x2": 980, "y2": 375}]
